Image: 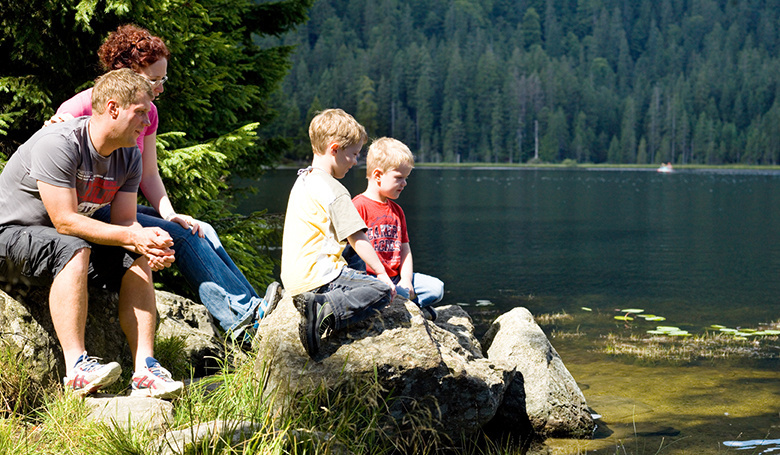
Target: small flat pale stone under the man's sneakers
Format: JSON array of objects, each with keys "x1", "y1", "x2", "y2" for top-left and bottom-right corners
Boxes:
[{"x1": 85, "y1": 395, "x2": 173, "y2": 433}]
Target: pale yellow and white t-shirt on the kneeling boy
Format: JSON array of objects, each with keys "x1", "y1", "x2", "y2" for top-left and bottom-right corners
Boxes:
[{"x1": 282, "y1": 168, "x2": 366, "y2": 295}]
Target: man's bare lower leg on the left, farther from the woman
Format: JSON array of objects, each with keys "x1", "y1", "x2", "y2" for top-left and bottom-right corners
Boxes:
[{"x1": 49, "y1": 248, "x2": 91, "y2": 376}]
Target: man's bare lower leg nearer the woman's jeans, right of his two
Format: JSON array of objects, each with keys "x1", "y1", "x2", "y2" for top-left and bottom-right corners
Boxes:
[{"x1": 119, "y1": 256, "x2": 157, "y2": 371}]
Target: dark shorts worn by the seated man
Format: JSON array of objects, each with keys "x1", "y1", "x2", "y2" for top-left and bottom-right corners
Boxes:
[{"x1": 0, "y1": 225, "x2": 139, "y2": 291}]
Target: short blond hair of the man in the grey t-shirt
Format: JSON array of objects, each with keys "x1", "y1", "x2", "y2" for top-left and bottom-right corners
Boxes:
[{"x1": 92, "y1": 68, "x2": 154, "y2": 114}]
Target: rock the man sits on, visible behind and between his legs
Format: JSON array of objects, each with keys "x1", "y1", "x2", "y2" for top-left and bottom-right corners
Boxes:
[{"x1": 0, "y1": 288, "x2": 224, "y2": 385}]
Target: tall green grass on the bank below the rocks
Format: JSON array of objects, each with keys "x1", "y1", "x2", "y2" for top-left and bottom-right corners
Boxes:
[{"x1": 0, "y1": 340, "x2": 523, "y2": 455}]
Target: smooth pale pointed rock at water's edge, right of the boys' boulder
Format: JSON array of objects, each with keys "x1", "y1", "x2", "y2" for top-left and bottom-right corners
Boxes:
[{"x1": 483, "y1": 308, "x2": 594, "y2": 437}]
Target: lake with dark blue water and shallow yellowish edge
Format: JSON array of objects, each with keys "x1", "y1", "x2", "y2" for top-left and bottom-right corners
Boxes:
[{"x1": 238, "y1": 168, "x2": 780, "y2": 454}]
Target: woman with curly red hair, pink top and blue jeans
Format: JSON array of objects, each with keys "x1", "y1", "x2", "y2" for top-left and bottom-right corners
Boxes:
[{"x1": 51, "y1": 25, "x2": 281, "y2": 342}]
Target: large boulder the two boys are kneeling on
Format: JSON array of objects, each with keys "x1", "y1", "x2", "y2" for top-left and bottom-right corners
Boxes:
[{"x1": 255, "y1": 296, "x2": 512, "y2": 439}]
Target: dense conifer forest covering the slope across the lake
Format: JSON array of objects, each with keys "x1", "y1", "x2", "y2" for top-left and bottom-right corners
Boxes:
[{"x1": 263, "y1": 0, "x2": 780, "y2": 165}]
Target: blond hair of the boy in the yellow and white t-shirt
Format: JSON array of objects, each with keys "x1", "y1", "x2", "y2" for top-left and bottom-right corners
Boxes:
[{"x1": 309, "y1": 109, "x2": 368, "y2": 155}]
